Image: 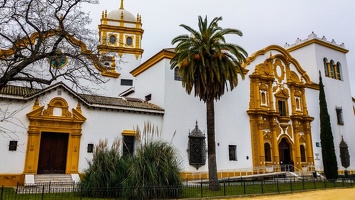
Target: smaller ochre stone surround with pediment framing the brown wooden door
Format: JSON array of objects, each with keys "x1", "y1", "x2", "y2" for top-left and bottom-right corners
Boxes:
[{"x1": 24, "y1": 97, "x2": 86, "y2": 174}]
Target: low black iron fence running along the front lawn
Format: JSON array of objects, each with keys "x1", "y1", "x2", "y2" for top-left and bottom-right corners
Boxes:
[{"x1": 0, "y1": 177, "x2": 354, "y2": 200}]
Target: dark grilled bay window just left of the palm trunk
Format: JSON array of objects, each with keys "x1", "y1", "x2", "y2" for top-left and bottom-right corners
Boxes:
[{"x1": 187, "y1": 121, "x2": 207, "y2": 169}]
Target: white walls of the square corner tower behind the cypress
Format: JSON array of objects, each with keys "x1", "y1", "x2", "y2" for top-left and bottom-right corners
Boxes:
[{"x1": 291, "y1": 44, "x2": 355, "y2": 169}]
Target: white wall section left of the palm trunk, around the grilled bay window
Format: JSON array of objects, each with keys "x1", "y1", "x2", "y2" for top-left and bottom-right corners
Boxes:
[{"x1": 163, "y1": 62, "x2": 207, "y2": 171}]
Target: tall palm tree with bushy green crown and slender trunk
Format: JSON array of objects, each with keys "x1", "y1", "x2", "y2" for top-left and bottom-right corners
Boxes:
[{"x1": 170, "y1": 16, "x2": 248, "y2": 190}]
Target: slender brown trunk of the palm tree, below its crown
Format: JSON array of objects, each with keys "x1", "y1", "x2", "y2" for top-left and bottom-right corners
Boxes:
[{"x1": 206, "y1": 99, "x2": 220, "y2": 190}]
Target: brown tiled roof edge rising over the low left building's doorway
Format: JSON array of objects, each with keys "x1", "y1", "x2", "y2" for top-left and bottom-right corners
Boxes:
[{"x1": 0, "y1": 83, "x2": 164, "y2": 113}]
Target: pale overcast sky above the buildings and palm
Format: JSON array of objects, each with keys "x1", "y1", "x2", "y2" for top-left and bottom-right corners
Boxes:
[{"x1": 85, "y1": 0, "x2": 355, "y2": 96}]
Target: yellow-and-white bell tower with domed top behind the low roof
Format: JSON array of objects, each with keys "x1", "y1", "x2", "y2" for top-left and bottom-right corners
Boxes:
[{"x1": 98, "y1": 0, "x2": 144, "y2": 96}]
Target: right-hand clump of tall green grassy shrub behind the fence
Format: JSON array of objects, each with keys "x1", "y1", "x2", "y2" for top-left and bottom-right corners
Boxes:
[{"x1": 123, "y1": 141, "x2": 181, "y2": 199}]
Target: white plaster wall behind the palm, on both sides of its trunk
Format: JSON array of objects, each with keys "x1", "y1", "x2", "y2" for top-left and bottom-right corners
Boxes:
[{"x1": 159, "y1": 57, "x2": 252, "y2": 172}]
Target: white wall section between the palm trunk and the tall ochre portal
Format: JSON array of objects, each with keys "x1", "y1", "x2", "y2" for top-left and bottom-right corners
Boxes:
[{"x1": 215, "y1": 74, "x2": 253, "y2": 170}]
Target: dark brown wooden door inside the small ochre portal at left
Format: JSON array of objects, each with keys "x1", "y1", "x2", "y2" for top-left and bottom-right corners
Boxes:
[{"x1": 37, "y1": 133, "x2": 69, "y2": 174}]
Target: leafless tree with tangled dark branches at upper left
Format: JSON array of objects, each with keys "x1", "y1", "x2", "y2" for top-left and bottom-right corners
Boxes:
[{"x1": 0, "y1": 0, "x2": 117, "y2": 91}]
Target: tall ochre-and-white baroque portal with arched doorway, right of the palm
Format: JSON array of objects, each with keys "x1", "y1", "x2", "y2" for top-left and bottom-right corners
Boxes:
[{"x1": 247, "y1": 45, "x2": 317, "y2": 169}]
